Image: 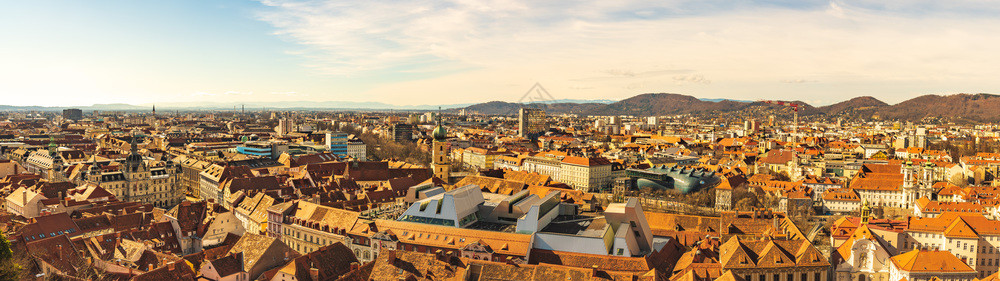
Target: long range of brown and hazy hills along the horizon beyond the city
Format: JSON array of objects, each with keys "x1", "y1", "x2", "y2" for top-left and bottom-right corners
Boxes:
[{"x1": 7, "y1": 93, "x2": 1000, "y2": 122}]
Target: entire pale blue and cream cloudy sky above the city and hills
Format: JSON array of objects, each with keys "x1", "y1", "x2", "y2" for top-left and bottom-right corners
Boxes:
[{"x1": 0, "y1": 0, "x2": 1000, "y2": 106}]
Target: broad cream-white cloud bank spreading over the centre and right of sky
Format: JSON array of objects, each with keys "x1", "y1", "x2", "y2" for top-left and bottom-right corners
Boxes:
[{"x1": 252, "y1": 0, "x2": 1000, "y2": 104}]
